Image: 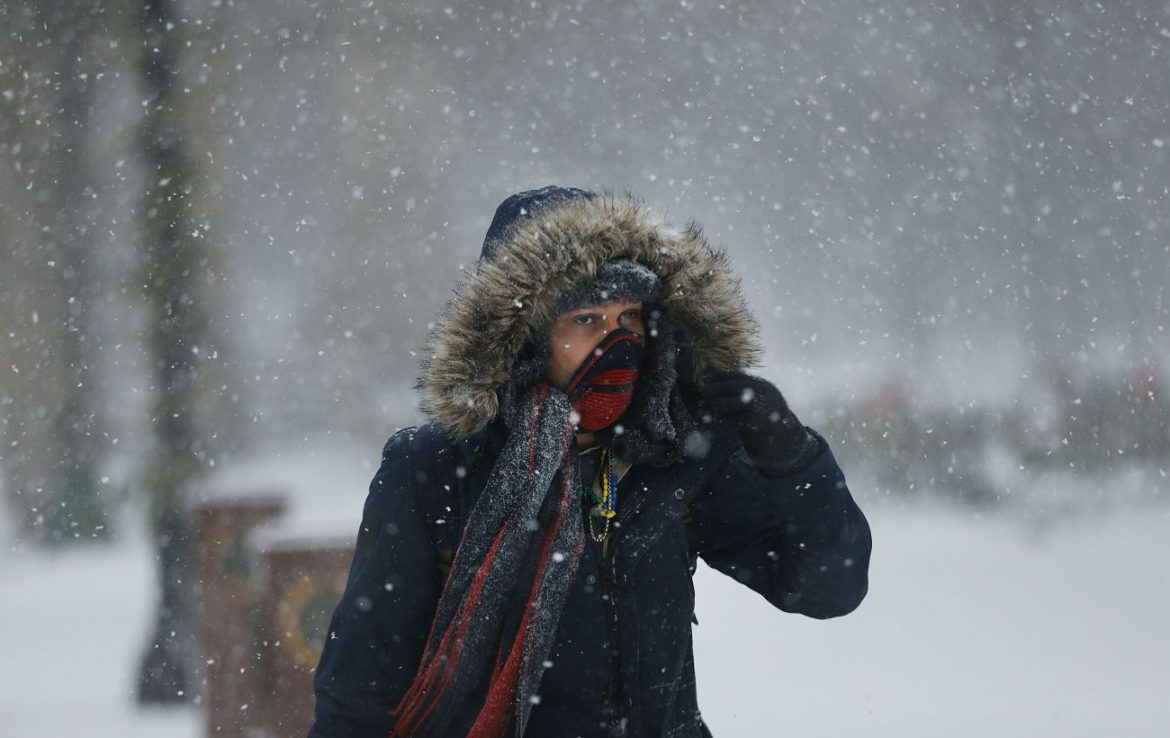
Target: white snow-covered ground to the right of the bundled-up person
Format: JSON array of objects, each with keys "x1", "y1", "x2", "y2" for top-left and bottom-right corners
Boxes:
[{"x1": 695, "y1": 506, "x2": 1170, "y2": 738}]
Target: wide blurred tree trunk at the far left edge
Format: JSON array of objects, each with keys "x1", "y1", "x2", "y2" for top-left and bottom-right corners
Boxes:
[{"x1": 0, "y1": 0, "x2": 109, "y2": 544}]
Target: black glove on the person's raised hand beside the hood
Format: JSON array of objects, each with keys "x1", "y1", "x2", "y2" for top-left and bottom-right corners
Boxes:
[{"x1": 698, "y1": 372, "x2": 820, "y2": 476}]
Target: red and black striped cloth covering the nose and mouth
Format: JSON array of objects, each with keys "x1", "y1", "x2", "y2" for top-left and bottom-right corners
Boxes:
[{"x1": 565, "y1": 327, "x2": 646, "y2": 430}]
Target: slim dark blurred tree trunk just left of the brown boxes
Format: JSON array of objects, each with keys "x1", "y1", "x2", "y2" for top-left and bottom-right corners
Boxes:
[{"x1": 137, "y1": 0, "x2": 208, "y2": 704}]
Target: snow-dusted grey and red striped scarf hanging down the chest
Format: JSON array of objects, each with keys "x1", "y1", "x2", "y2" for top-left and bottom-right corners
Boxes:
[{"x1": 391, "y1": 382, "x2": 585, "y2": 738}]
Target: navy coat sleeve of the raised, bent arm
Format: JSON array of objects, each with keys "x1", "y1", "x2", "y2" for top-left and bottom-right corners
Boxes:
[{"x1": 689, "y1": 428, "x2": 872, "y2": 618}]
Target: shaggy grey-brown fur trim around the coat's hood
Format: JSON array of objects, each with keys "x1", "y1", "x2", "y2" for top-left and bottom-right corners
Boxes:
[{"x1": 417, "y1": 194, "x2": 761, "y2": 439}]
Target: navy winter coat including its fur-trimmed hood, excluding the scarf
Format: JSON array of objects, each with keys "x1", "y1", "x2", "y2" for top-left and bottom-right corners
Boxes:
[{"x1": 310, "y1": 187, "x2": 870, "y2": 738}]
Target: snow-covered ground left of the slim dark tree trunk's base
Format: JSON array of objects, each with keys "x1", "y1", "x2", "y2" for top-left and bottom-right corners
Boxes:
[{"x1": 0, "y1": 516, "x2": 201, "y2": 738}]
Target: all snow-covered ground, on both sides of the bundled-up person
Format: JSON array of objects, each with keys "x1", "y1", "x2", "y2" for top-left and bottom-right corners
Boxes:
[{"x1": 0, "y1": 504, "x2": 1170, "y2": 738}]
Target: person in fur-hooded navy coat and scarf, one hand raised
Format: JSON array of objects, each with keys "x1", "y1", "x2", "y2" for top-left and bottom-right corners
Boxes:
[{"x1": 311, "y1": 187, "x2": 870, "y2": 738}]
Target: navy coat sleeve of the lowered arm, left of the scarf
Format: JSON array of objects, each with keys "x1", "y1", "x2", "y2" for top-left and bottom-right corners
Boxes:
[{"x1": 309, "y1": 429, "x2": 439, "y2": 738}]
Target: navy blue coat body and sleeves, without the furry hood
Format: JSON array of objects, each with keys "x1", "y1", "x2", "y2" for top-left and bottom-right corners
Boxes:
[{"x1": 310, "y1": 421, "x2": 870, "y2": 738}]
